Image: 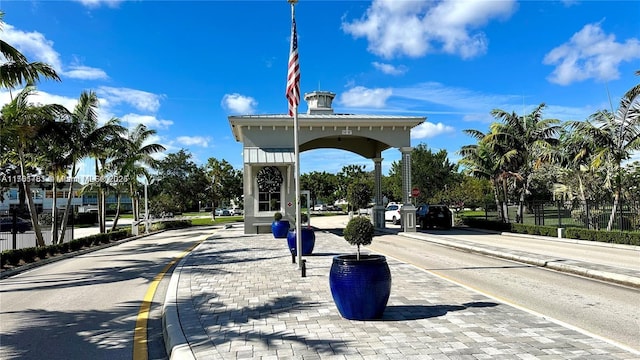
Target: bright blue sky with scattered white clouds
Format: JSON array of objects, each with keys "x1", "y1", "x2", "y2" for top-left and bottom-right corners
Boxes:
[{"x1": 0, "y1": 0, "x2": 640, "y2": 175}]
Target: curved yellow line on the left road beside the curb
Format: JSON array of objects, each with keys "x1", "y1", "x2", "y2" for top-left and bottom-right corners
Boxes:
[{"x1": 133, "y1": 235, "x2": 211, "y2": 360}]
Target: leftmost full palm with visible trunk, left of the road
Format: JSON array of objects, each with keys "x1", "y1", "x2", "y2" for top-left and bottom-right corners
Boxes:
[{"x1": 0, "y1": 86, "x2": 67, "y2": 246}]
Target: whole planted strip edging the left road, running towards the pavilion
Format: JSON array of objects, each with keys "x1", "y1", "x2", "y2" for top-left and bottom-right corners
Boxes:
[{"x1": 0, "y1": 220, "x2": 191, "y2": 277}]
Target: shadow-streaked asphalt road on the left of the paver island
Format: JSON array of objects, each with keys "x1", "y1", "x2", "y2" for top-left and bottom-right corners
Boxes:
[{"x1": 0, "y1": 228, "x2": 211, "y2": 360}]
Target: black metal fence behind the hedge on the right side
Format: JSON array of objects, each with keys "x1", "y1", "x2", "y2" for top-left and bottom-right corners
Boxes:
[{"x1": 485, "y1": 200, "x2": 640, "y2": 231}]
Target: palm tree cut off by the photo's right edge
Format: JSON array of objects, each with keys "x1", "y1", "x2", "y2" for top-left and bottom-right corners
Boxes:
[{"x1": 570, "y1": 76, "x2": 640, "y2": 231}]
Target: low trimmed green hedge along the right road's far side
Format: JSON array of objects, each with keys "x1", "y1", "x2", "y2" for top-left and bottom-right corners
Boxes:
[{"x1": 462, "y1": 217, "x2": 640, "y2": 245}]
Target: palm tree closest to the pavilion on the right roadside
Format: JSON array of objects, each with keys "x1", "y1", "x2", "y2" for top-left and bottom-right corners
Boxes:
[{"x1": 486, "y1": 103, "x2": 561, "y2": 222}]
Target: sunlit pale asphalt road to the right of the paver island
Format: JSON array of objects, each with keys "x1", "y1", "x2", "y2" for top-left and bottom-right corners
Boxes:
[{"x1": 312, "y1": 217, "x2": 640, "y2": 351}]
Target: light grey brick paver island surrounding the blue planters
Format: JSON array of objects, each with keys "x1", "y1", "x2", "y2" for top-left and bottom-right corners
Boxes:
[{"x1": 174, "y1": 227, "x2": 638, "y2": 359}]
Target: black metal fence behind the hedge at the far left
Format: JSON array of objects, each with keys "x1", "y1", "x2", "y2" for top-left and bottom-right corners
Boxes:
[{"x1": 0, "y1": 212, "x2": 74, "y2": 251}]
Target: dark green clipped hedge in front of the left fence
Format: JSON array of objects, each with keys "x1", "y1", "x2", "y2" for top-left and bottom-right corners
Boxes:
[{"x1": 0, "y1": 229, "x2": 131, "y2": 267}]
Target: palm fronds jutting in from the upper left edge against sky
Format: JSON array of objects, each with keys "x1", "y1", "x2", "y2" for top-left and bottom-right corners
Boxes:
[{"x1": 0, "y1": 11, "x2": 60, "y2": 90}]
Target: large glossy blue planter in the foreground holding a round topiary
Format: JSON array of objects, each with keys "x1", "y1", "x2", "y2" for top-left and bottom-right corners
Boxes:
[{"x1": 329, "y1": 255, "x2": 391, "y2": 320}]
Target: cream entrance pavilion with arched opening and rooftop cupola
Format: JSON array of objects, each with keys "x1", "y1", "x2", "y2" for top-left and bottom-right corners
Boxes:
[{"x1": 229, "y1": 91, "x2": 426, "y2": 234}]
